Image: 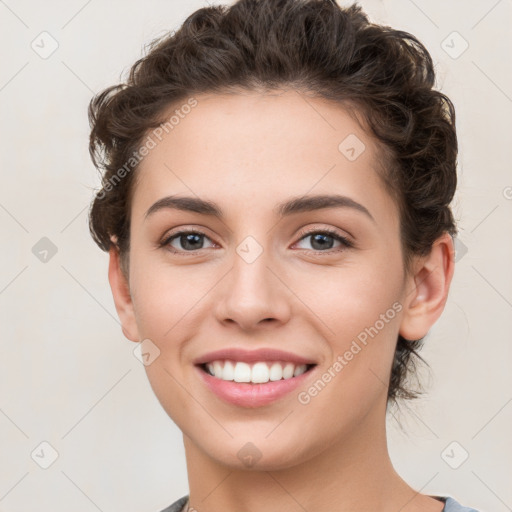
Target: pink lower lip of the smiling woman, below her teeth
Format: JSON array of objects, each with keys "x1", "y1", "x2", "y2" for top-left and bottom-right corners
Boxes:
[{"x1": 196, "y1": 366, "x2": 314, "y2": 407}]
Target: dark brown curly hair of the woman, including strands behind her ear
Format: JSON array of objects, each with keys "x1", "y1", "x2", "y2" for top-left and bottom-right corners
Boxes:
[{"x1": 89, "y1": 0, "x2": 457, "y2": 403}]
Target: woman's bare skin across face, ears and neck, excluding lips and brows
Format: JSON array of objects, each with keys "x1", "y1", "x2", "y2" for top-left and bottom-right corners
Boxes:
[{"x1": 109, "y1": 90, "x2": 454, "y2": 512}]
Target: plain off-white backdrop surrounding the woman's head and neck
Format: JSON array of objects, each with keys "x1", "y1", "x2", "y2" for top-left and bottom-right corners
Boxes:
[{"x1": 0, "y1": 0, "x2": 512, "y2": 512}]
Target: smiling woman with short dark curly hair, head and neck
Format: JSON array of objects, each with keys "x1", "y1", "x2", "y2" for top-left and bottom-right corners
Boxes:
[{"x1": 86, "y1": 0, "x2": 473, "y2": 512}]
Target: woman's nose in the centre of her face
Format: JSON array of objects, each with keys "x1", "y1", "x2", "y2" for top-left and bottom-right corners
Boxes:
[{"x1": 215, "y1": 244, "x2": 293, "y2": 331}]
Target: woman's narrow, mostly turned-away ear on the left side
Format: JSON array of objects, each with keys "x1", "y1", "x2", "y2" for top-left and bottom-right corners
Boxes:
[{"x1": 108, "y1": 241, "x2": 140, "y2": 342}]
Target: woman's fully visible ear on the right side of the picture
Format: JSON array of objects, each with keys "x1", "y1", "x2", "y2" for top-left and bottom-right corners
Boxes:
[{"x1": 399, "y1": 233, "x2": 455, "y2": 340}]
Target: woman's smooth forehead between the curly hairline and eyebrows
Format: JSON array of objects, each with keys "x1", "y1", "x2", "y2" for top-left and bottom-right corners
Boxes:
[{"x1": 132, "y1": 90, "x2": 396, "y2": 227}]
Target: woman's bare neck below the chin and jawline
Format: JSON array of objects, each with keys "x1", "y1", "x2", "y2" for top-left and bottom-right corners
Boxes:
[{"x1": 184, "y1": 404, "x2": 443, "y2": 512}]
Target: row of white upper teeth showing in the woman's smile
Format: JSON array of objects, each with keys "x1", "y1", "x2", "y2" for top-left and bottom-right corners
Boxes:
[{"x1": 206, "y1": 360, "x2": 307, "y2": 384}]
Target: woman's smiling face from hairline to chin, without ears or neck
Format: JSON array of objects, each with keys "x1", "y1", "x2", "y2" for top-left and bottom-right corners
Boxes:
[{"x1": 115, "y1": 87, "x2": 420, "y2": 469}]
